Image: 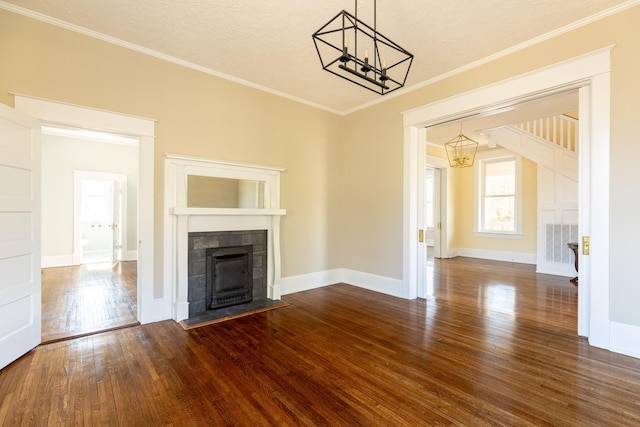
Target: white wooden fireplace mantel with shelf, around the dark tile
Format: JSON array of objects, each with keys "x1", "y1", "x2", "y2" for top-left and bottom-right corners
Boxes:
[{"x1": 164, "y1": 155, "x2": 286, "y2": 321}]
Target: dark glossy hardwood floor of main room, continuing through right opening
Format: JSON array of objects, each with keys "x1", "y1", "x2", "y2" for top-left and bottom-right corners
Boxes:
[{"x1": 0, "y1": 258, "x2": 640, "y2": 426}]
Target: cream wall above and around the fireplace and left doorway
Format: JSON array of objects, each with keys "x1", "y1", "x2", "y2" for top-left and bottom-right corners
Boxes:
[{"x1": 0, "y1": 10, "x2": 340, "y2": 297}]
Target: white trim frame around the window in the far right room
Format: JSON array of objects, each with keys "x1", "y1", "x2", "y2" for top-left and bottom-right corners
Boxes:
[{"x1": 473, "y1": 148, "x2": 523, "y2": 239}]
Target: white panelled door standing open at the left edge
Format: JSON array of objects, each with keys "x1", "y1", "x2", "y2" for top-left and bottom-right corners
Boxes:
[{"x1": 0, "y1": 104, "x2": 42, "y2": 368}]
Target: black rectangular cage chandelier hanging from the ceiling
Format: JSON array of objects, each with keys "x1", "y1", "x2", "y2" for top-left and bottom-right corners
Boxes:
[{"x1": 313, "y1": 0, "x2": 413, "y2": 95}]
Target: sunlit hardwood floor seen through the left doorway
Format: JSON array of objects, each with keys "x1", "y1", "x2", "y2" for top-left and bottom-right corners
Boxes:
[{"x1": 42, "y1": 261, "x2": 138, "y2": 343}]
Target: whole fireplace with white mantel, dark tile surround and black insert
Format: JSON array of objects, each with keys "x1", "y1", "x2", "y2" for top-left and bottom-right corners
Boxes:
[{"x1": 163, "y1": 154, "x2": 286, "y2": 323}]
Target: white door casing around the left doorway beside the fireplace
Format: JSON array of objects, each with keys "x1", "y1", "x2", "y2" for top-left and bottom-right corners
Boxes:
[{"x1": 13, "y1": 94, "x2": 160, "y2": 323}]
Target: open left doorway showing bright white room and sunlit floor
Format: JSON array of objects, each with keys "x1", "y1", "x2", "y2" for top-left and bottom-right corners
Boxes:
[{"x1": 41, "y1": 125, "x2": 138, "y2": 342}]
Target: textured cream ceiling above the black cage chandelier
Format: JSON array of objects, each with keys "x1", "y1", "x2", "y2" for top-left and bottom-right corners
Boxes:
[{"x1": 0, "y1": 0, "x2": 638, "y2": 113}]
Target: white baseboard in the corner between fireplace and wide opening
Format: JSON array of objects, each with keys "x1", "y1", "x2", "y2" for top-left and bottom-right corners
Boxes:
[{"x1": 280, "y1": 268, "x2": 402, "y2": 297}]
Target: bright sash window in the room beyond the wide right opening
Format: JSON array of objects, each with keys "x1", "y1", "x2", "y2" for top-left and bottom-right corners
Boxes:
[{"x1": 476, "y1": 156, "x2": 521, "y2": 235}]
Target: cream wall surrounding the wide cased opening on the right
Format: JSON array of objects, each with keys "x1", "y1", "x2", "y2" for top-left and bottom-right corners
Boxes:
[{"x1": 338, "y1": 6, "x2": 640, "y2": 326}]
